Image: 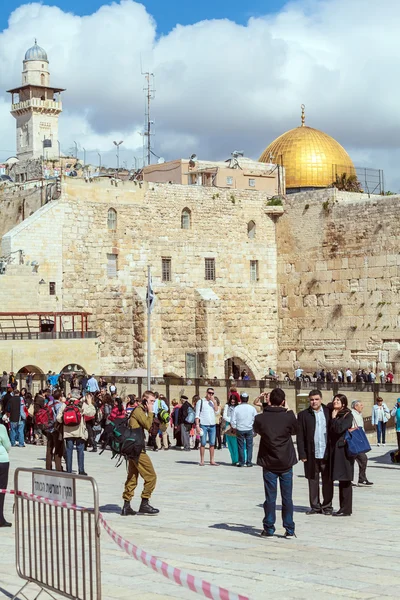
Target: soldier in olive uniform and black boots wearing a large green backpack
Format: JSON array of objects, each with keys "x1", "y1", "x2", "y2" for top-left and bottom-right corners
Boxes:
[{"x1": 121, "y1": 391, "x2": 160, "y2": 517}]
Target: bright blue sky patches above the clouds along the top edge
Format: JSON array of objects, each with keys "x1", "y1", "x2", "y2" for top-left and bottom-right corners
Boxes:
[{"x1": 0, "y1": 0, "x2": 287, "y2": 34}]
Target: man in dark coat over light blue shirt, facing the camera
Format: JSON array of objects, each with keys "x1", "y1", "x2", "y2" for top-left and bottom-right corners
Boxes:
[{"x1": 297, "y1": 390, "x2": 333, "y2": 515}]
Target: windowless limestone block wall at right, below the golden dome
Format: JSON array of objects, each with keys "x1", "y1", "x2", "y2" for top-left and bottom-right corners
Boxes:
[{"x1": 277, "y1": 189, "x2": 400, "y2": 380}]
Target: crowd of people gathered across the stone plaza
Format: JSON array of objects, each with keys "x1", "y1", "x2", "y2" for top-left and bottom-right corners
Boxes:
[{"x1": 0, "y1": 374, "x2": 400, "y2": 537}]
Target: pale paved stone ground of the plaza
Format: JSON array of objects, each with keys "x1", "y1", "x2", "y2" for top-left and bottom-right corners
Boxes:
[{"x1": 0, "y1": 446, "x2": 400, "y2": 600}]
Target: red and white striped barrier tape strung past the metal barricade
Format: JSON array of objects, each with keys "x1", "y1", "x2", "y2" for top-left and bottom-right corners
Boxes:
[{"x1": 0, "y1": 489, "x2": 249, "y2": 600}]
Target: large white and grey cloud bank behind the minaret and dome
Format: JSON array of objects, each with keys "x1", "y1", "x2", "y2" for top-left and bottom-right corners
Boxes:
[{"x1": 0, "y1": 0, "x2": 400, "y2": 190}]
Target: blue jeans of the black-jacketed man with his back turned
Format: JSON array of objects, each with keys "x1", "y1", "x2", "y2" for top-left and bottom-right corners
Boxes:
[{"x1": 263, "y1": 469, "x2": 294, "y2": 535}]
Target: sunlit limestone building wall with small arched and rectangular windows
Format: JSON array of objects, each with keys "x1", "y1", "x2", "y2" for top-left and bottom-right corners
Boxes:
[{"x1": 0, "y1": 179, "x2": 282, "y2": 378}]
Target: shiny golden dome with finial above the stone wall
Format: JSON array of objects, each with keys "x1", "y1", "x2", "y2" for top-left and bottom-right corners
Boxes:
[{"x1": 259, "y1": 105, "x2": 356, "y2": 191}]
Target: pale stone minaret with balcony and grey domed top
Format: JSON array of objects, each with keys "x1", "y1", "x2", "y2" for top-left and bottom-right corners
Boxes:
[{"x1": 8, "y1": 40, "x2": 64, "y2": 160}]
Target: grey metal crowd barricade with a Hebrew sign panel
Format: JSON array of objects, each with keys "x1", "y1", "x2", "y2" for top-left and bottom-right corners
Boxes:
[{"x1": 14, "y1": 468, "x2": 101, "y2": 600}]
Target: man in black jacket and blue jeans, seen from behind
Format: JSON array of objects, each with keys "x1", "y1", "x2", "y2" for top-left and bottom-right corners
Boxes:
[{"x1": 254, "y1": 388, "x2": 297, "y2": 538}]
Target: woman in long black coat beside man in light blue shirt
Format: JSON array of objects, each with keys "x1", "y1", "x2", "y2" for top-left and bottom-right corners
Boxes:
[{"x1": 329, "y1": 394, "x2": 354, "y2": 517}]
